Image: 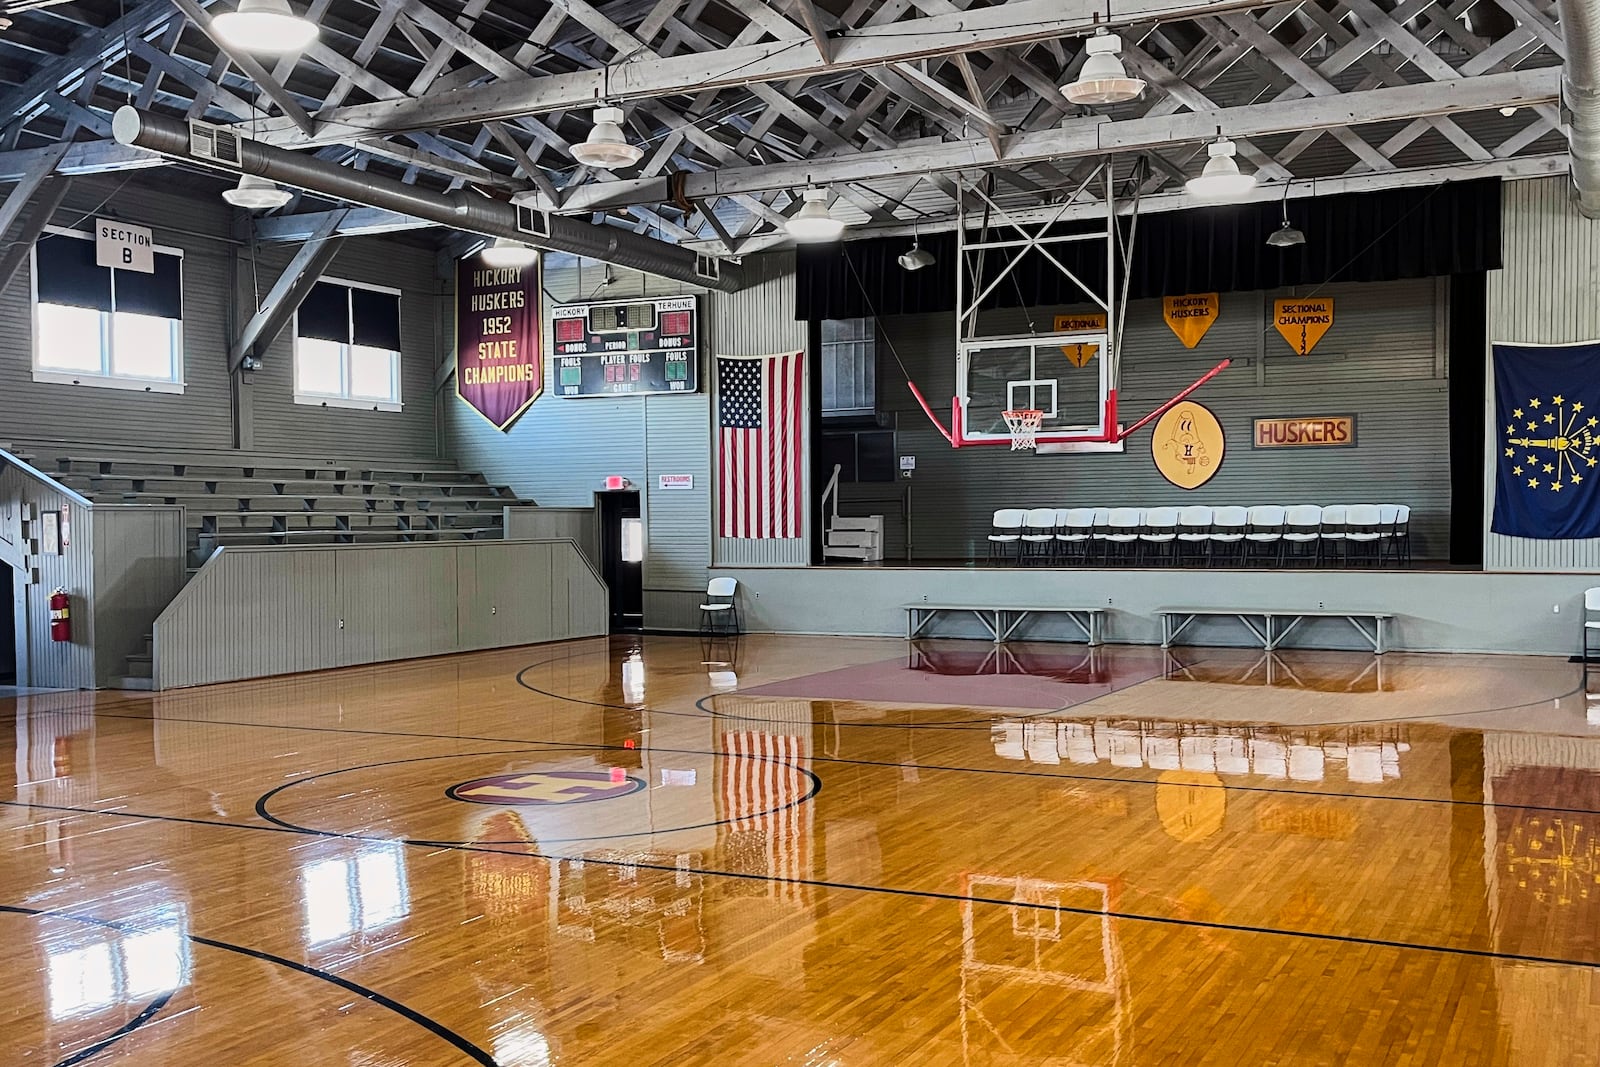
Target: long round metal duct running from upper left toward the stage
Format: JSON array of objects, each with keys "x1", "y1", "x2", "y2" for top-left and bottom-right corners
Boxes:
[{"x1": 112, "y1": 107, "x2": 744, "y2": 293}]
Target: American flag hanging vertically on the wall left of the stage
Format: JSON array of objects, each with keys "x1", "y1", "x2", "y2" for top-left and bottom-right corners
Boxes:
[{"x1": 717, "y1": 352, "x2": 805, "y2": 539}]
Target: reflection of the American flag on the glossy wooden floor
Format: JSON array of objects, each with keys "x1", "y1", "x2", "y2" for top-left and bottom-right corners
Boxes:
[{"x1": 718, "y1": 701, "x2": 813, "y2": 904}]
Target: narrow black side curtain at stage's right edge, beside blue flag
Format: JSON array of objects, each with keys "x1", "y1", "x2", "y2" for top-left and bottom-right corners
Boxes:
[{"x1": 1450, "y1": 270, "x2": 1488, "y2": 566}]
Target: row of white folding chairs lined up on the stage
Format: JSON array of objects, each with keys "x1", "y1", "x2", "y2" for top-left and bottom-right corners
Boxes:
[{"x1": 989, "y1": 504, "x2": 1411, "y2": 566}]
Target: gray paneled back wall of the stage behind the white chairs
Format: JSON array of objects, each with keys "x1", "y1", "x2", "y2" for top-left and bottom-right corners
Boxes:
[{"x1": 876, "y1": 280, "x2": 1450, "y2": 558}]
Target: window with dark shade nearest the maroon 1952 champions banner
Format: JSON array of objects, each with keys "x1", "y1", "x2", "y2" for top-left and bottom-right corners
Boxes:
[{"x1": 294, "y1": 280, "x2": 400, "y2": 411}]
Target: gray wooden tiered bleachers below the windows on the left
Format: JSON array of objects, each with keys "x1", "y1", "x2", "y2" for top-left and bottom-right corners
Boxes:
[{"x1": 26, "y1": 445, "x2": 520, "y2": 571}]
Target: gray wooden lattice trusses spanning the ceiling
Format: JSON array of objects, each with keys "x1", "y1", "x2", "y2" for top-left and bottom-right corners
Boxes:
[{"x1": 0, "y1": 0, "x2": 1565, "y2": 254}]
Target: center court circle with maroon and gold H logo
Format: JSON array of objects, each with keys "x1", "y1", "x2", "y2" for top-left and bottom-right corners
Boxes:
[{"x1": 256, "y1": 747, "x2": 822, "y2": 848}]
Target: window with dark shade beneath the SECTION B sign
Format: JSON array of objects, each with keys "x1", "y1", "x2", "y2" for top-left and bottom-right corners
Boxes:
[{"x1": 34, "y1": 227, "x2": 184, "y2": 394}]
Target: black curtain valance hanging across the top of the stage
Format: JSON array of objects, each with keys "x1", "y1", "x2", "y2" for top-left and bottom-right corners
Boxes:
[{"x1": 795, "y1": 178, "x2": 1501, "y2": 320}]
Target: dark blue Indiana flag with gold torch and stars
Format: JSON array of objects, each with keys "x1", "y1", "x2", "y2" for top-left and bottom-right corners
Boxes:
[{"x1": 1490, "y1": 342, "x2": 1600, "y2": 539}]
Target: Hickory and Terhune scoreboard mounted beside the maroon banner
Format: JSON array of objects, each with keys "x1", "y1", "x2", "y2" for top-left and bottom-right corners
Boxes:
[{"x1": 550, "y1": 296, "x2": 699, "y2": 397}]
